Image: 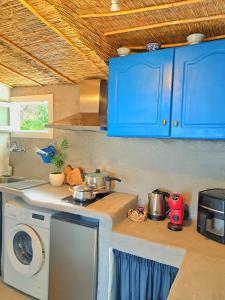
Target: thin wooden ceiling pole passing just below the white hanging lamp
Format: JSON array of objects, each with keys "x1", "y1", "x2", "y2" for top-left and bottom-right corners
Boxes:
[{"x1": 79, "y1": 0, "x2": 202, "y2": 19}]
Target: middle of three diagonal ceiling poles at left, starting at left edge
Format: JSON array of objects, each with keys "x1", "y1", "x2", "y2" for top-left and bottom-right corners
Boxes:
[{"x1": 0, "y1": 34, "x2": 77, "y2": 84}]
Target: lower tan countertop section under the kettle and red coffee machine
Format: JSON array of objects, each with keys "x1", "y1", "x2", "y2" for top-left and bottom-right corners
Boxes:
[{"x1": 113, "y1": 218, "x2": 225, "y2": 300}]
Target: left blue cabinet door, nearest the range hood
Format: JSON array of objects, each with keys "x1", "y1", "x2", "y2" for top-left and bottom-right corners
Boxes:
[{"x1": 108, "y1": 49, "x2": 174, "y2": 137}]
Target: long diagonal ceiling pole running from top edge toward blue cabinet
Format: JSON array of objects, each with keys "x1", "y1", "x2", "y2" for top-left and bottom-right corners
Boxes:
[{"x1": 19, "y1": 0, "x2": 106, "y2": 75}]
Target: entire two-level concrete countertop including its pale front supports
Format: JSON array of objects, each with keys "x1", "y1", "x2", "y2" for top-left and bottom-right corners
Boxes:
[{"x1": 0, "y1": 184, "x2": 225, "y2": 300}]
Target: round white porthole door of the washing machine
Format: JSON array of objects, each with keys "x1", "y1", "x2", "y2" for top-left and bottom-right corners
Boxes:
[{"x1": 7, "y1": 224, "x2": 44, "y2": 277}]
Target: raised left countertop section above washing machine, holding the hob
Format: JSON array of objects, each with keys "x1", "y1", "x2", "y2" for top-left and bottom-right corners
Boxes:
[{"x1": 0, "y1": 184, "x2": 137, "y2": 229}]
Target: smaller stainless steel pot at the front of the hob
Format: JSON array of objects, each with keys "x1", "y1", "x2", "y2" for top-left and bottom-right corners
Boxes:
[{"x1": 69, "y1": 185, "x2": 98, "y2": 202}]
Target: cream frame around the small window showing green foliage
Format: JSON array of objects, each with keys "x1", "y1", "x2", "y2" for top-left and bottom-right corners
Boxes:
[{"x1": 9, "y1": 94, "x2": 53, "y2": 139}]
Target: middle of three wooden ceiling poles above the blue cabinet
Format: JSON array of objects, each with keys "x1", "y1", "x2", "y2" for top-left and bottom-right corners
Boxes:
[{"x1": 104, "y1": 14, "x2": 225, "y2": 36}]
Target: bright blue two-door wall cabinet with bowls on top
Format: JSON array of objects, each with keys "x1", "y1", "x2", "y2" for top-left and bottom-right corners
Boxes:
[{"x1": 108, "y1": 40, "x2": 225, "y2": 139}]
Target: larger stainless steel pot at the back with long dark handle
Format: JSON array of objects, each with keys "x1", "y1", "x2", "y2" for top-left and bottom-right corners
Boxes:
[{"x1": 84, "y1": 169, "x2": 121, "y2": 193}]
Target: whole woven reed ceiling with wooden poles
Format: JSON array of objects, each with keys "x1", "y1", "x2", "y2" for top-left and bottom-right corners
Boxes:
[{"x1": 0, "y1": 0, "x2": 225, "y2": 86}]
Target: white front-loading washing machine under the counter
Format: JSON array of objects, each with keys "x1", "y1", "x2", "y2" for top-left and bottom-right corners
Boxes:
[{"x1": 3, "y1": 200, "x2": 52, "y2": 300}]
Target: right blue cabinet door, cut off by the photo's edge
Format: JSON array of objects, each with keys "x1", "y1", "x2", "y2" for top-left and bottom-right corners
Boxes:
[{"x1": 171, "y1": 40, "x2": 225, "y2": 139}]
